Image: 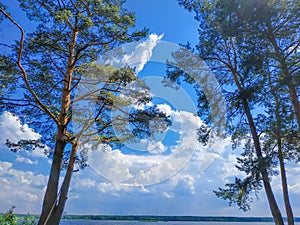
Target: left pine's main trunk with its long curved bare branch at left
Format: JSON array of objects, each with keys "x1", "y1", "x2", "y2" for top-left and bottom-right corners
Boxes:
[{"x1": 0, "y1": 8, "x2": 78, "y2": 225}]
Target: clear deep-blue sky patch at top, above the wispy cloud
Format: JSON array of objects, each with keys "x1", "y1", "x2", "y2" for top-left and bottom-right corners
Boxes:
[{"x1": 126, "y1": 0, "x2": 198, "y2": 44}]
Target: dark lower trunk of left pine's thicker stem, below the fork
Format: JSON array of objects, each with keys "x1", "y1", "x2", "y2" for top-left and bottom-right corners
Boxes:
[{"x1": 38, "y1": 128, "x2": 66, "y2": 225}]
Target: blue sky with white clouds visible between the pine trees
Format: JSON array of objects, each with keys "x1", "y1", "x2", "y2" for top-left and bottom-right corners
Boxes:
[{"x1": 0, "y1": 0, "x2": 300, "y2": 216}]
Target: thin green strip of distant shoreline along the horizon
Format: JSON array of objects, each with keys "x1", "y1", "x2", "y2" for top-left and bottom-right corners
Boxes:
[{"x1": 55, "y1": 215, "x2": 300, "y2": 222}]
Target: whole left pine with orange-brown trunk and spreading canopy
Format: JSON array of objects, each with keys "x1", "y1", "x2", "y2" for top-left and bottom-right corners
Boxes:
[{"x1": 0, "y1": 0, "x2": 169, "y2": 225}]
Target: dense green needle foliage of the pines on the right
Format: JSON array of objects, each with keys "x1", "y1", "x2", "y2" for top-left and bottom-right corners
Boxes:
[{"x1": 177, "y1": 0, "x2": 300, "y2": 214}]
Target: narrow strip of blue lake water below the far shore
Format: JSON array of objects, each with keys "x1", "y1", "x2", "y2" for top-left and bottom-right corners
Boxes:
[{"x1": 60, "y1": 220, "x2": 300, "y2": 225}]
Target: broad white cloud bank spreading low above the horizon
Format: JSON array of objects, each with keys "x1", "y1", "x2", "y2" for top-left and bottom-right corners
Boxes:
[{"x1": 0, "y1": 110, "x2": 300, "y2": 216}]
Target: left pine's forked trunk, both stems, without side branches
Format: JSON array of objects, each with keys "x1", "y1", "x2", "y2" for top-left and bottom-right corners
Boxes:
[{"x1": 38, "y1": 23, "x2": 78, "y2": 225}]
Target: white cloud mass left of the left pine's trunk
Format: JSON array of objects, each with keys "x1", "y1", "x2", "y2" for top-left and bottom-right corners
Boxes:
[{"x1": 0, "y1": 111, "x2": 47, "y2": 213}]
